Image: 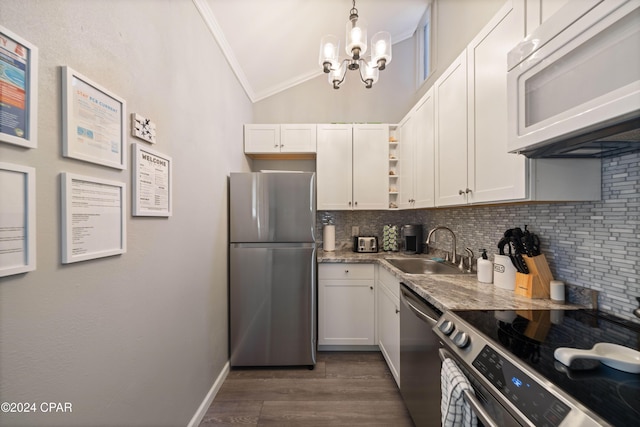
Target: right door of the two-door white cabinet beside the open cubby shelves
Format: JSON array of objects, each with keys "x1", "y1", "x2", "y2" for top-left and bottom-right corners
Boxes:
[{"x1": 413, "y1": 90, "x2": 435, "y2": 208}]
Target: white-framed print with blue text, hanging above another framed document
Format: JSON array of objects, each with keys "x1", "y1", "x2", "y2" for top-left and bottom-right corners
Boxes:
[{"x1": 62, "y1": 67, "x2": 127, "y2": 169}]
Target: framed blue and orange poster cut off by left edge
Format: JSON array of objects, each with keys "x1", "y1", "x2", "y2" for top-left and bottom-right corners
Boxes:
[{"x1": 0, "y1": 25, "x2": 38, "y2": 148}]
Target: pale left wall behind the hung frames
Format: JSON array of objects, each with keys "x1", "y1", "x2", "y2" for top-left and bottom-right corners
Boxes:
[{"x1": 0, "y1": 0, "x2": 252, "y2": 426}]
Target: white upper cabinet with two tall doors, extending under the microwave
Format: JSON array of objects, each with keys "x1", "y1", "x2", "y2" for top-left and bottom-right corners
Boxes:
[{"x1": 434, "y1": 0, "x2": 601, "y2": 206}]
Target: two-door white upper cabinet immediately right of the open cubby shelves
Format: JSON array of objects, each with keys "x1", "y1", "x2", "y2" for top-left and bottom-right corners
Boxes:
[{"x1": 398, "y1": 90, "x2": 435, "y2": 209}]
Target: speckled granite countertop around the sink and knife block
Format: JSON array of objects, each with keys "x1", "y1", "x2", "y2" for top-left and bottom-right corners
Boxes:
[{"x1": 317, "y1": 250, "x2": 584, "y2": 311}]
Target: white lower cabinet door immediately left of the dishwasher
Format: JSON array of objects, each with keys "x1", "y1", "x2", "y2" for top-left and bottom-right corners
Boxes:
[{"x1": 376, "y1": 267, "x2": 400, "y2": 386}]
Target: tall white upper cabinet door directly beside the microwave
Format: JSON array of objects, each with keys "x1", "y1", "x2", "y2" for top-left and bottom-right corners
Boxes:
[{"x1": 467, "y1": 0, "x2": 527, "y2": 203}]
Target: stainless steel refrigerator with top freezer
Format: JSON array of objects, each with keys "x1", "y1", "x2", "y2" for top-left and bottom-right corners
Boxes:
[{"x1": 229, "y1": 172, "x2": 316, "y2": 366}]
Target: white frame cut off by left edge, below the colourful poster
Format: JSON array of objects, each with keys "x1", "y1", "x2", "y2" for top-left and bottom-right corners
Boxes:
[{"x1": 0, "y1": 162, "x2": 36, "y2": 277}]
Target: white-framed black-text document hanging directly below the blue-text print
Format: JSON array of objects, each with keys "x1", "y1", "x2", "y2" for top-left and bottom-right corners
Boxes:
[{"x1": 60, "y1": 172, "x2": 127, "y2": 264}]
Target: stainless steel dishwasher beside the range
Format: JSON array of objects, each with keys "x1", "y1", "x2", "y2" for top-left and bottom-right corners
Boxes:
[{"x1": 400, "y1": 282, "x2": 442, "y2": 427}]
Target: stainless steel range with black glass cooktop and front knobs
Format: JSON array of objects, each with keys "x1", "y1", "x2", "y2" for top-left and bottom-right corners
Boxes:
[{"x1": 434, "y1": 310, "x2": 640, "y2": 426}]
